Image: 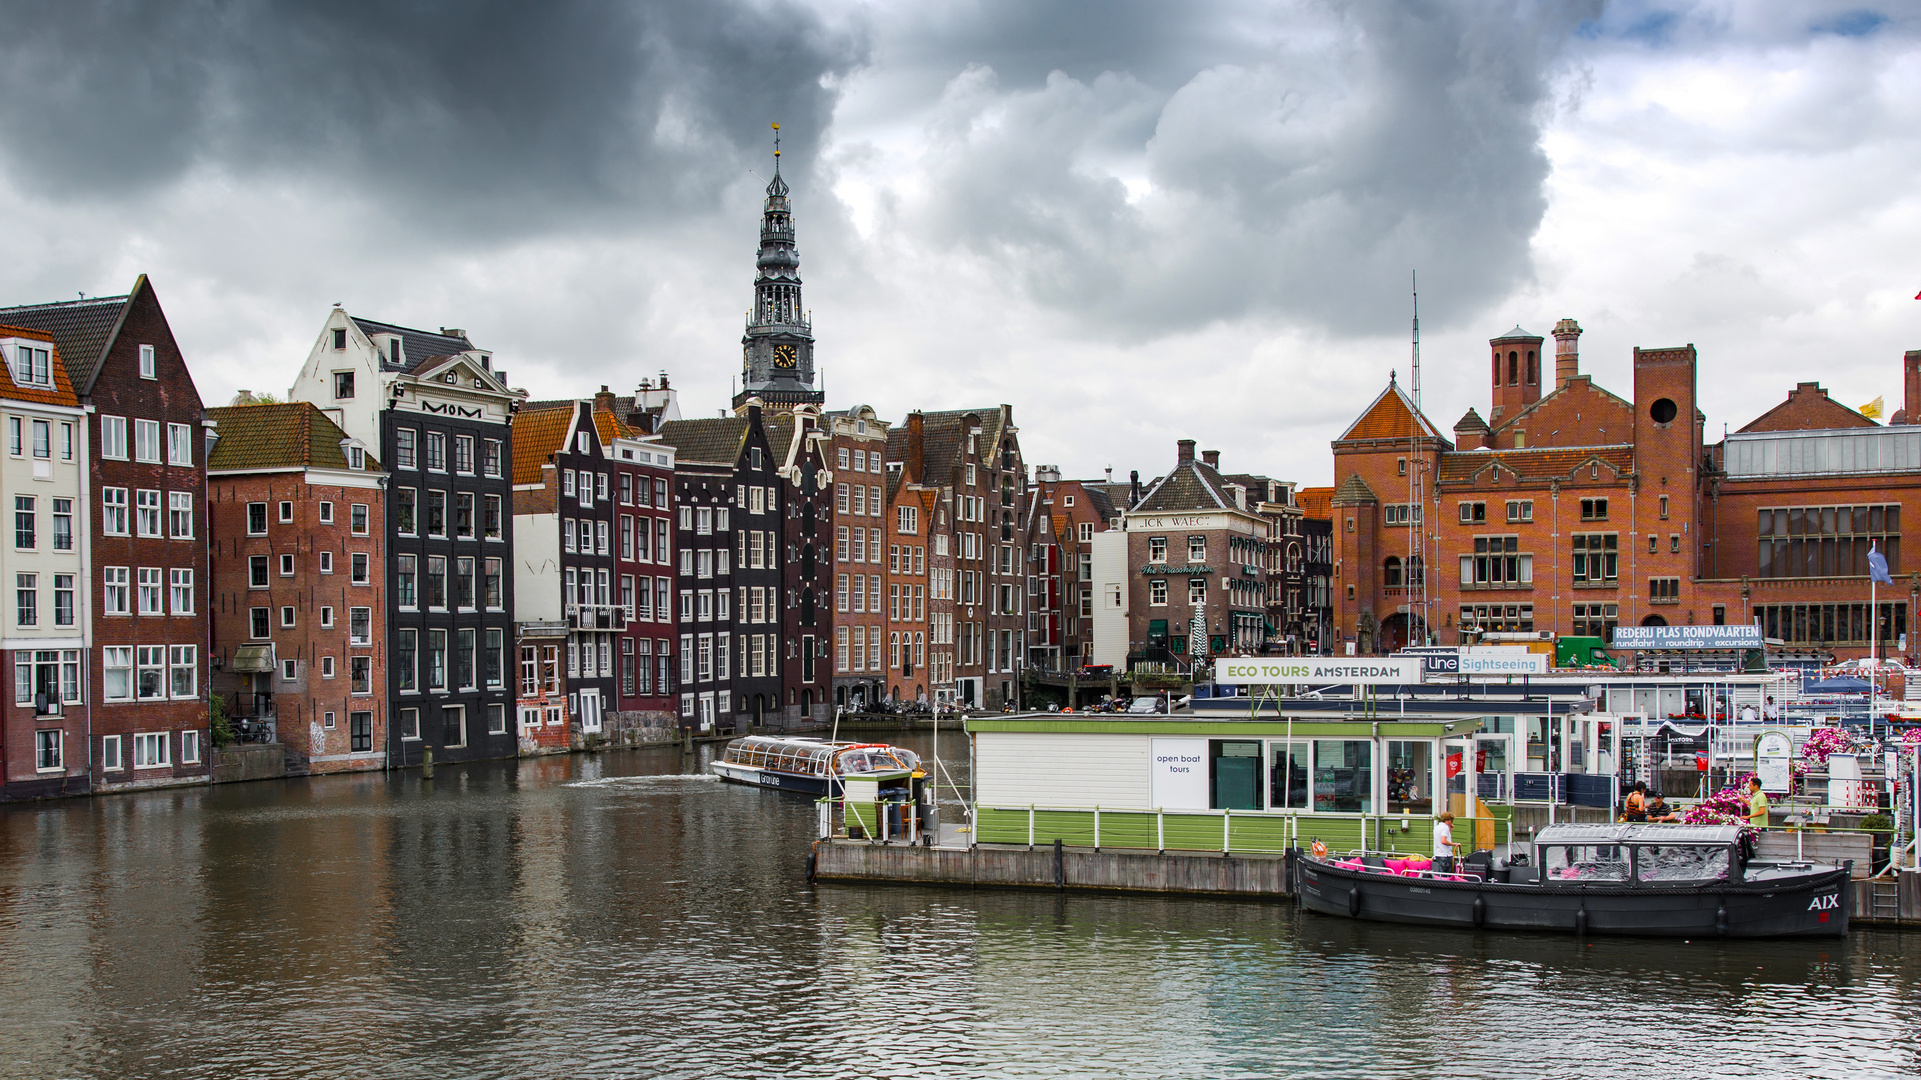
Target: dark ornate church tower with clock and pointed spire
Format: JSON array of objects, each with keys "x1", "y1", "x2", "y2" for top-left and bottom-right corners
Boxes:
[{"x1": 734, "y1": 123, "x2": 826, "y2": 415}]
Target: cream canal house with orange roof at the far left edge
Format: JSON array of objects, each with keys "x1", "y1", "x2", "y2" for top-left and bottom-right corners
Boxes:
[{"x1": 0, "y1": 325, "x2": 92, "y2": 799}]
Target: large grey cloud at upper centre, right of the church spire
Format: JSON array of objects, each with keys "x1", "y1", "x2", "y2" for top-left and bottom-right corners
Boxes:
[{"x1": 891, "y1": 4, "x2": 1594, "y2": 332}]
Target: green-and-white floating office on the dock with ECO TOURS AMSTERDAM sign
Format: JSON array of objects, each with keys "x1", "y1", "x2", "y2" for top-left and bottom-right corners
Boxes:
[{"x1": 966, "y1": 659, "x2": 1616, "y2": 853}]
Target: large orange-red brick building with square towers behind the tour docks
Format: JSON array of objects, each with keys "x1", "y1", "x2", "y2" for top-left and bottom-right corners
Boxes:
[{"x1": 1329, "y1": 319, "x2": 1921, "y2": 655}]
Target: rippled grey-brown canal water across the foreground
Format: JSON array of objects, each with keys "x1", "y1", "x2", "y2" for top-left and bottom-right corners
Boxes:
[{"x1": 0, "y1": 738, "x2": 1921, "y2": 1080}]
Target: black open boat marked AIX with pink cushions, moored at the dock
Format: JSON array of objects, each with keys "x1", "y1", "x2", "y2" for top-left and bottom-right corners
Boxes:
[{"x1": 1289, "y1": 824, "x2": 1854, "y2": 938}]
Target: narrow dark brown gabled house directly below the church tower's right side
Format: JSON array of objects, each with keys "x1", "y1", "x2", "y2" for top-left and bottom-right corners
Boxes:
[{"x1": 765, "y1": 404, "x2": 834, "y2": 723}]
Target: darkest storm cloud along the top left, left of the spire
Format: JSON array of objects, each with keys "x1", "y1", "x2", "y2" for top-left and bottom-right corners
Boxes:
[{"x1": 0, "y1": 0, "x2": 863, "y2": 233}]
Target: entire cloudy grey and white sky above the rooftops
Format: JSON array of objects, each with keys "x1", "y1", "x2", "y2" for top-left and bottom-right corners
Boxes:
[{"x1": 0, "y1": 0, "x2": 1921, "y2": 484}]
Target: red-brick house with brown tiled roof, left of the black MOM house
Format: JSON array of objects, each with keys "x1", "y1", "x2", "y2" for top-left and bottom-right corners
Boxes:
[{"x1": 207, "y1": 402, "x2": 390, "y2": 774}]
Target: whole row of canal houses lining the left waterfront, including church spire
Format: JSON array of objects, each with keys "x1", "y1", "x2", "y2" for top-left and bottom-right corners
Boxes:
[{"x1": 0, "y1": 159, "x2": 1327, "y2": 798}]
